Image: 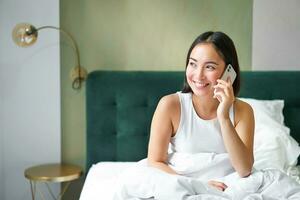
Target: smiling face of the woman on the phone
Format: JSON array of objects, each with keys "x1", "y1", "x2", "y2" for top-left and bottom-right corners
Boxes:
[{"x1": 186, "y1": 43, "x2": 225, "y2": 96}]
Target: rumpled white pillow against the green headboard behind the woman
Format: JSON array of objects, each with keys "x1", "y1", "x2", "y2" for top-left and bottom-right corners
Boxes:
[{"x1": 239, "y1": 98, "x2": 300, "y2": 172}]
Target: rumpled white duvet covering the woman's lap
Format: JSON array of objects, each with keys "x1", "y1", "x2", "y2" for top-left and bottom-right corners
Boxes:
[{"x1": 113, "y1": 155, "x2": 300, "y2": 200}]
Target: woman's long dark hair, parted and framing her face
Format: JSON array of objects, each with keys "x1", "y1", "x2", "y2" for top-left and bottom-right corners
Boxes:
[{"x1": 182, "y1": 31, "x2": 240, "y2": 96}]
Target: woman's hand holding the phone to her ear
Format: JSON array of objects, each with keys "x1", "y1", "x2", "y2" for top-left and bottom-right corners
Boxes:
[{"x1": 214, "y1": 78, "x2": 235, "y2": 120}]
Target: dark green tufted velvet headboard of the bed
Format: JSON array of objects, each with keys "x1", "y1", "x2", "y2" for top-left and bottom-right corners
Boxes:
[{"x1": 86, "y1": 71, "x2": 300, "y2": 169}]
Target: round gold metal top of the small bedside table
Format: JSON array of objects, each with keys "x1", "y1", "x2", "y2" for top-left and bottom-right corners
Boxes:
[{"x1": 24, "y1": 163, "x2": 82, "y2": 182}]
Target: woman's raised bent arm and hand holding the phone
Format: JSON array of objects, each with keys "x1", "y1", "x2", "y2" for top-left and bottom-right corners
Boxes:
[{"x1": 215, "y1": 80, "x2": 254, "y2": 177}]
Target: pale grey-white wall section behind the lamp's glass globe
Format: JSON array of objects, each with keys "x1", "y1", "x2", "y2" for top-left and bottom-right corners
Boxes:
[{"x1": 0, "y1": 0, "x2": 61, "y2": 200}]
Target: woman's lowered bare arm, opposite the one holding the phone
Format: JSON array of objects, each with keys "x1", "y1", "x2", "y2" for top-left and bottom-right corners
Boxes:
[{"x1": 148, "y1": 94, "x2": 180, "y2": 174}]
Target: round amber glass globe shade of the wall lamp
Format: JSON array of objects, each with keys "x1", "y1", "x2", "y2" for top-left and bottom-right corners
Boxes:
[{"x1": 12, "y1": 23, "x2": 38, "y2": 47}]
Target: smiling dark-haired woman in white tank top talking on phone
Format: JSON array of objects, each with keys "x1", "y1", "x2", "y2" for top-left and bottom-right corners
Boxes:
[{"x1": 148, "y1": 32, "x2": 254, "y2": 181}]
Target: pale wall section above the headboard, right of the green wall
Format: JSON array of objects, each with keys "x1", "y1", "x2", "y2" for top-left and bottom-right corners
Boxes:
[{"x1": 252, "y1": 0, "x2": 300, "y2": 70}]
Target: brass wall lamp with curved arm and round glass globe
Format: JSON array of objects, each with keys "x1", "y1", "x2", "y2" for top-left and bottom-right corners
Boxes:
[{"x1": 12, "y1": 23, "x2": 87, "y2": 90}]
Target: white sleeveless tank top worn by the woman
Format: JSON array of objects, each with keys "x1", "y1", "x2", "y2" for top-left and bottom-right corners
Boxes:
[{"x1": 169, "y1": 92, "x2": 234, "y2": 154}]
